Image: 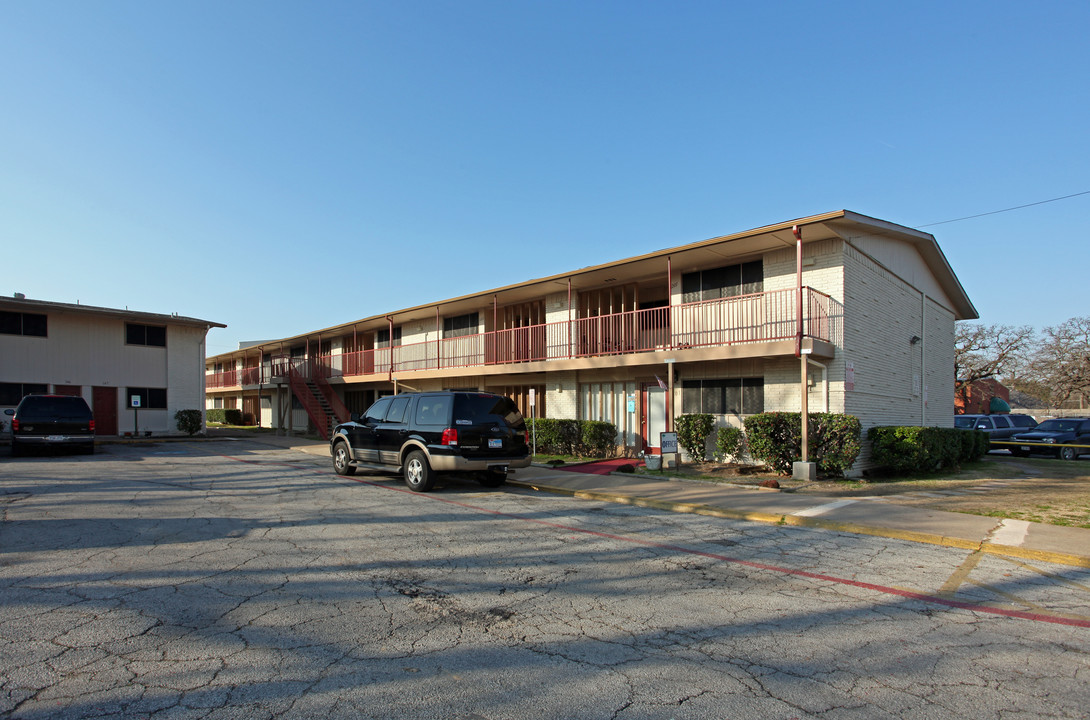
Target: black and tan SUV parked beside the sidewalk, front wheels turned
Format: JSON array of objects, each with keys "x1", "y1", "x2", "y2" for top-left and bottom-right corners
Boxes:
[{"x1": 329, "y1": 391, "x2": 530, "y2": 492}]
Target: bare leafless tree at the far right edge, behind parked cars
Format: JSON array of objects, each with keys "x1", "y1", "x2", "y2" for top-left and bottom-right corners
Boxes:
[{"x1": 1029, "y1": 317, "x2": 1090, "y2": 407}]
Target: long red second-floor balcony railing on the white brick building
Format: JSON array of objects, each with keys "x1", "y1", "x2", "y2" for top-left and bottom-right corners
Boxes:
[{"x1": 207, "y1": 288, "x2": 844, "y2": 388}]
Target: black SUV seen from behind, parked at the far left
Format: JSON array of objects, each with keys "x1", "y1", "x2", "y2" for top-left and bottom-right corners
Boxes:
[{"x1": 4, "y1": 395, "x2": 95, "y2": 456}]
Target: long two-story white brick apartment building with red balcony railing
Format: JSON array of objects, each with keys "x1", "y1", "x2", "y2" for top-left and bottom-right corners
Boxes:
[{"x1": 207, "y1": 210, "x2": 978, "y2": 459}]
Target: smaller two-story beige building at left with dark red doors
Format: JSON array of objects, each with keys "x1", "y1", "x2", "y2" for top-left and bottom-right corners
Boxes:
[{"x1": 0, "y1": 295, "x2": 227, "y2": 436}]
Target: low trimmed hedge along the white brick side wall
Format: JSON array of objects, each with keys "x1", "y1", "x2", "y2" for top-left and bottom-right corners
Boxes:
[{"x1": 867, "y1": 425, "x2": 989, "y2": 473}]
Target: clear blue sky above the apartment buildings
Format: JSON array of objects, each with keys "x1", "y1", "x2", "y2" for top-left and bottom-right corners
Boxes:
[{"x1": 0, "y1": 0, "x2": 1090, "y2": 354}]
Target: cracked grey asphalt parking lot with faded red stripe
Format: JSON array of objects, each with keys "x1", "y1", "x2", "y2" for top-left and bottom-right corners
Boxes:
[{"x1": 0, "y1": 441, "x2": 1090, "y2": 720}]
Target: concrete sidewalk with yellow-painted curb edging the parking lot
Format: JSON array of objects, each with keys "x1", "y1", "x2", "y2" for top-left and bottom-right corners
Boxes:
[{"x1": 238, "y1": 435, "x2": 1090, "y2": 568}]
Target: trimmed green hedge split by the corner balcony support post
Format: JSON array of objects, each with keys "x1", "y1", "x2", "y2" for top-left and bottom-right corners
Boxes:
[{"x1": 744, "y1": 413, "x2": 862, "y2": 475}]
